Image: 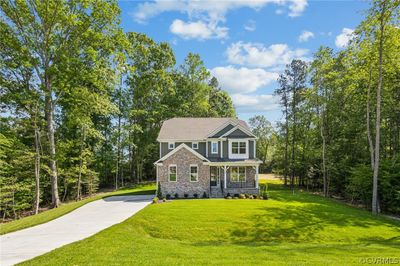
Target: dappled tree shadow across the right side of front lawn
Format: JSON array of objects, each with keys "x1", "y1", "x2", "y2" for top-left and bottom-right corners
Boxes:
[{"x1": 190, "y1": 185, "x2": 400, "y2": 247}]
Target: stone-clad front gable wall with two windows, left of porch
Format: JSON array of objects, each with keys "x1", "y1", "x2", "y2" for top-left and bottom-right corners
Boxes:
[{"x1": 157, "y1": 148, "x2": 210, "y2": 197}]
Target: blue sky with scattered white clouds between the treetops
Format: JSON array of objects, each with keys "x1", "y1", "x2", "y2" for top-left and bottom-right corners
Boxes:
[{"x1": 119, "y1": 0, "x2": 369, "y2": 122}]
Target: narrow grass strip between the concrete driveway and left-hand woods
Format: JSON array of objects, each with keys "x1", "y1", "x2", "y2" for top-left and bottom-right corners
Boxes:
[{"x1": 0, "y1": 184, "x2": 155, "y2": 235}]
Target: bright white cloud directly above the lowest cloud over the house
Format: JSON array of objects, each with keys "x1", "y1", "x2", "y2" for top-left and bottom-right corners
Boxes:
[{"x1": 210, "y1": 66, "x2": 278, "y2": 93}]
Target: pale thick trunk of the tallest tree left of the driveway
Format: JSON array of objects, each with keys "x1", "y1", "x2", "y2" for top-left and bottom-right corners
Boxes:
[{"x1": 45, "y1": 88, "x2": 60, "y2": 208}]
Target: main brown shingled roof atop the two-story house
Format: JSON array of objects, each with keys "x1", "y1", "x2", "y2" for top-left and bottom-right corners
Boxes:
[{"x1": 157, "y1": 117, "x2": 250, "y2": 141}]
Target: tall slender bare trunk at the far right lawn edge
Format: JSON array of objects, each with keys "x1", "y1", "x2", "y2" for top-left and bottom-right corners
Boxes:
[{"x1": 372, "y1": 1, "x2": 386, "y2": 214}]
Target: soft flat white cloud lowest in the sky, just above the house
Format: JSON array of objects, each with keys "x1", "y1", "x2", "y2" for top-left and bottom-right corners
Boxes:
[{"x1": 231, "y1": 94, "x2": 280, "y2": 113}]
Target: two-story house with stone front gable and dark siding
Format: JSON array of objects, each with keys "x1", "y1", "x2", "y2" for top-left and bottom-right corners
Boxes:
[{"x1": 154, "y1": 118, "x2": 261, "y2": 197}]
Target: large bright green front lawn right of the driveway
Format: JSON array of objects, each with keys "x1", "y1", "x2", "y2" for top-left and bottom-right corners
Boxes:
[{"x1": 19, "y1": 184, "x2": 400, "y2": 265}]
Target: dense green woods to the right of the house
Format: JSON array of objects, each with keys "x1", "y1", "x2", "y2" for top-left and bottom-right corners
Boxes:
[{"x1": 250, "y1": 0, "x2": 400, "y2": 214}]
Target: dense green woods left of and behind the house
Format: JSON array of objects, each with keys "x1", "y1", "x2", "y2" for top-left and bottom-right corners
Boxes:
[{"x1": 0, "y1": 0, "x2": 235, "y2": 219}]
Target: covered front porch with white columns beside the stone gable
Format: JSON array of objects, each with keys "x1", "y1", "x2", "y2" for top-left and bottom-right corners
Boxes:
[{"x1": 210, "y1": 163, "x2": 259, "y2": 198}]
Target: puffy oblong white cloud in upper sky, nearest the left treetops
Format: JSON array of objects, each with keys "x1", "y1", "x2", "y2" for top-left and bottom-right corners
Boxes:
[{"x1": 169, "y1": 19, "x2": 228, "y2": 40}]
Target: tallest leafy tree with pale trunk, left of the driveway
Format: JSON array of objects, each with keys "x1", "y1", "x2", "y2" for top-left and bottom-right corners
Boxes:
[{"x1": 0, "y1": 0, "x2": 122, "y2": 207}]
